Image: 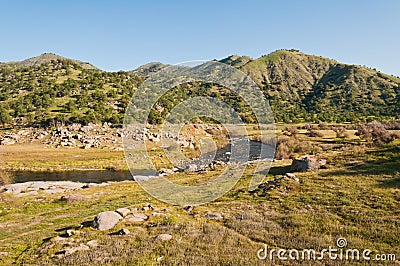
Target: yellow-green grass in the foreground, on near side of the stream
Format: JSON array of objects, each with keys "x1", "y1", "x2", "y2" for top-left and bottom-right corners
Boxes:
[{"x1": 0, "y1": 140, "x2": 400, "y2": 265}]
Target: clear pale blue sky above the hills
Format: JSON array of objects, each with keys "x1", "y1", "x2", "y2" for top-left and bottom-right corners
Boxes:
[{"x1": 0, "y1": 0, "x2": 400, "y2": 76}]
